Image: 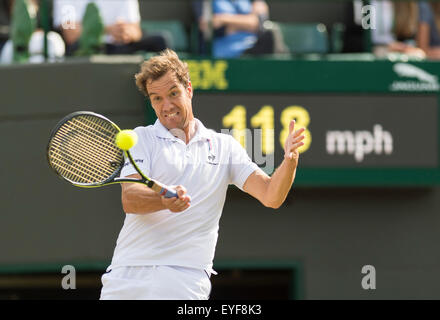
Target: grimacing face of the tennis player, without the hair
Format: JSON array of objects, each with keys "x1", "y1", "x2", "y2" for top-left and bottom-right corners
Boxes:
[{"x1": 147, "y1": 71, "x2": 194, "y2": 130}]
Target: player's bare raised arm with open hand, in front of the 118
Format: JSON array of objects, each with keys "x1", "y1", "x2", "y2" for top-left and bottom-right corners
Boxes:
[{"x1": 243, "y1": 120, "x2": 304, "y2": 209}]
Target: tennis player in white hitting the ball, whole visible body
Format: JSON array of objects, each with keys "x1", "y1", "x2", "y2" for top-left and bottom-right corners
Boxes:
[{"x1": 101, "y1": 49, "x2": 304, "y2": 300}]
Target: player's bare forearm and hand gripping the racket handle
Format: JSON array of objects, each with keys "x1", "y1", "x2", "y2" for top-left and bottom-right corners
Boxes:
[{"x1": 121, "y1": 174, "x2": 191, "y2": 214}]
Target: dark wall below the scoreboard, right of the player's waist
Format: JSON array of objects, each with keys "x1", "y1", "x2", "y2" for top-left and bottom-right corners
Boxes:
[{"x1": 222, "y1": 186, "x2": 440, "y2": 299}]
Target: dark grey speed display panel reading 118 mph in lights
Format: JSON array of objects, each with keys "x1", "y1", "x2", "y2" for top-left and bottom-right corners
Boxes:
[{"x1": 193, "y1": 92, "x2": 438, "y2": 184}]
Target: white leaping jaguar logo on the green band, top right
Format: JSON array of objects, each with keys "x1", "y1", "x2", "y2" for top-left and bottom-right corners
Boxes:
[{"x1": 390, "y1": 62, "x2": 440, "y2": 91}]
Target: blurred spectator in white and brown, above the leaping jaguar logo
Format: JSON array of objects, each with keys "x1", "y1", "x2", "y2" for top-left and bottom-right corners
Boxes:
[{"x1": 371, "y1": 0, "x2": 426, "y2": 58}]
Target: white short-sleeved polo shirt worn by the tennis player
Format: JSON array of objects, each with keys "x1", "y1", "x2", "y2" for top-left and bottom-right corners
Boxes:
[{"x1": 108, "y1": 119, "x2": 258, "y2": 270}]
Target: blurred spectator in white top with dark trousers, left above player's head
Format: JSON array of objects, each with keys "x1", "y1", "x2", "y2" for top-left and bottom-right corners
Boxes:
[{"x1": 53, "y1": 0, "x2": 167, "y2": 55}]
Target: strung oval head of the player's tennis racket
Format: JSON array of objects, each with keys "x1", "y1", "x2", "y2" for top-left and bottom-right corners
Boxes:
[{"x1": 49, "y1": 115, "x2": 123, "y2": 184}]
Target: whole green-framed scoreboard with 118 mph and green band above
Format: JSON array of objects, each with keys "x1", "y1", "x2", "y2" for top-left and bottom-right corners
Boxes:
[{"x1": 183, "y1": 60, "x2": 440, "y2": 186}]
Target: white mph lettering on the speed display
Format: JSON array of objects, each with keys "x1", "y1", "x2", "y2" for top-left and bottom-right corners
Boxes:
[{"x1": 326, "y1": 124, "x2": 393, "y2": 162}]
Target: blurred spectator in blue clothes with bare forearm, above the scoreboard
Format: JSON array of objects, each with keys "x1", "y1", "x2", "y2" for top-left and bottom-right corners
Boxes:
[{"x1": 194, "y1": 0, "x2": 274, "y2": 58}]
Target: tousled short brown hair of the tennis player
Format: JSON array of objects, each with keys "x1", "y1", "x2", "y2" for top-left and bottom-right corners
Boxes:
[{"x1": 134, "y1": 49, "x2": 189, "y2": 97}]
